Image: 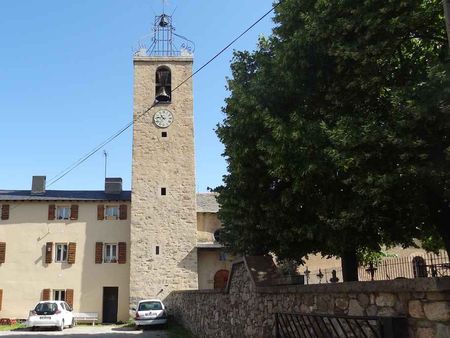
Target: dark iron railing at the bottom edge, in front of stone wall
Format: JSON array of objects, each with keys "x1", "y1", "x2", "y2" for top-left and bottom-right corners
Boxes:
[{"x1": 275, "y1": 313, "x2": 408, "y2": 338}]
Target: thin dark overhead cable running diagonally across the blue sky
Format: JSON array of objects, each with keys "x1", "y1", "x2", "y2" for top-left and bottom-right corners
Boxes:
[{"x1": 47, "y1": 0, "x2": 284, "y2": 187}]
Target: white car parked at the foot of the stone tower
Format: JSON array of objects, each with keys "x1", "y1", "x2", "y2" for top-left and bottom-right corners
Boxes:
[{"x1": 132, "y1": 299, "x2": 167, "y2": 328}]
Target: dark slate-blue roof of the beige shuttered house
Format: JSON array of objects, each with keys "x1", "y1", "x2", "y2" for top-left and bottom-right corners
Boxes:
[{"x1": 0, "y1": 190, "x2": 131, "y2": 201}]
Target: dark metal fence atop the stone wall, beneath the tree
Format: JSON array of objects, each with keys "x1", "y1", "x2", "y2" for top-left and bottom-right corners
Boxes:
[{"x1": 301, "y1": 252, "x2": 450, "y2": 284}]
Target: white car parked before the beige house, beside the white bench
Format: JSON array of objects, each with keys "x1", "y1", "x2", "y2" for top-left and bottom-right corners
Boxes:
[{"x1": 26, "y1": 300, "x2": 73, "y2": 331}]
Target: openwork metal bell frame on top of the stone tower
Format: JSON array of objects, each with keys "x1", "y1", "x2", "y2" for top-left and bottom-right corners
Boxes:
[{"x1": 148, "y1": 13, "x2": 180, "y2": 56}]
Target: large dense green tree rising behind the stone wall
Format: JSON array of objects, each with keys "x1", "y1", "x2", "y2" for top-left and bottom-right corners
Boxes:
[{"x1": 216, "y1": 0, "x2": 450, "y2": 279}]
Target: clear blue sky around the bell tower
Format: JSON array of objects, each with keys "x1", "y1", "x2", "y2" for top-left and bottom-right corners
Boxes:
[{"x1": 0, "y1": 0, "x2": 274, "y2": 192}]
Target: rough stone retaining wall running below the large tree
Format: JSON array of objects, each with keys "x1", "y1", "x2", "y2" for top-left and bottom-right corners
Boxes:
[{"x1": 165, "y1": 258, "x2": 450, "y2": 338}]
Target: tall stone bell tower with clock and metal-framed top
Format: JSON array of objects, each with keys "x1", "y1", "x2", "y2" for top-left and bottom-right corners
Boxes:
[{"x1": 130, "y1": 14, "x2": 198, "y2": 304}]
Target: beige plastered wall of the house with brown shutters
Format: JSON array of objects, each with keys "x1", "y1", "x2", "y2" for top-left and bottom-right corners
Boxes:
[{"x1": 0, "y1": 202, "x2": 130, "y2": 321}]
